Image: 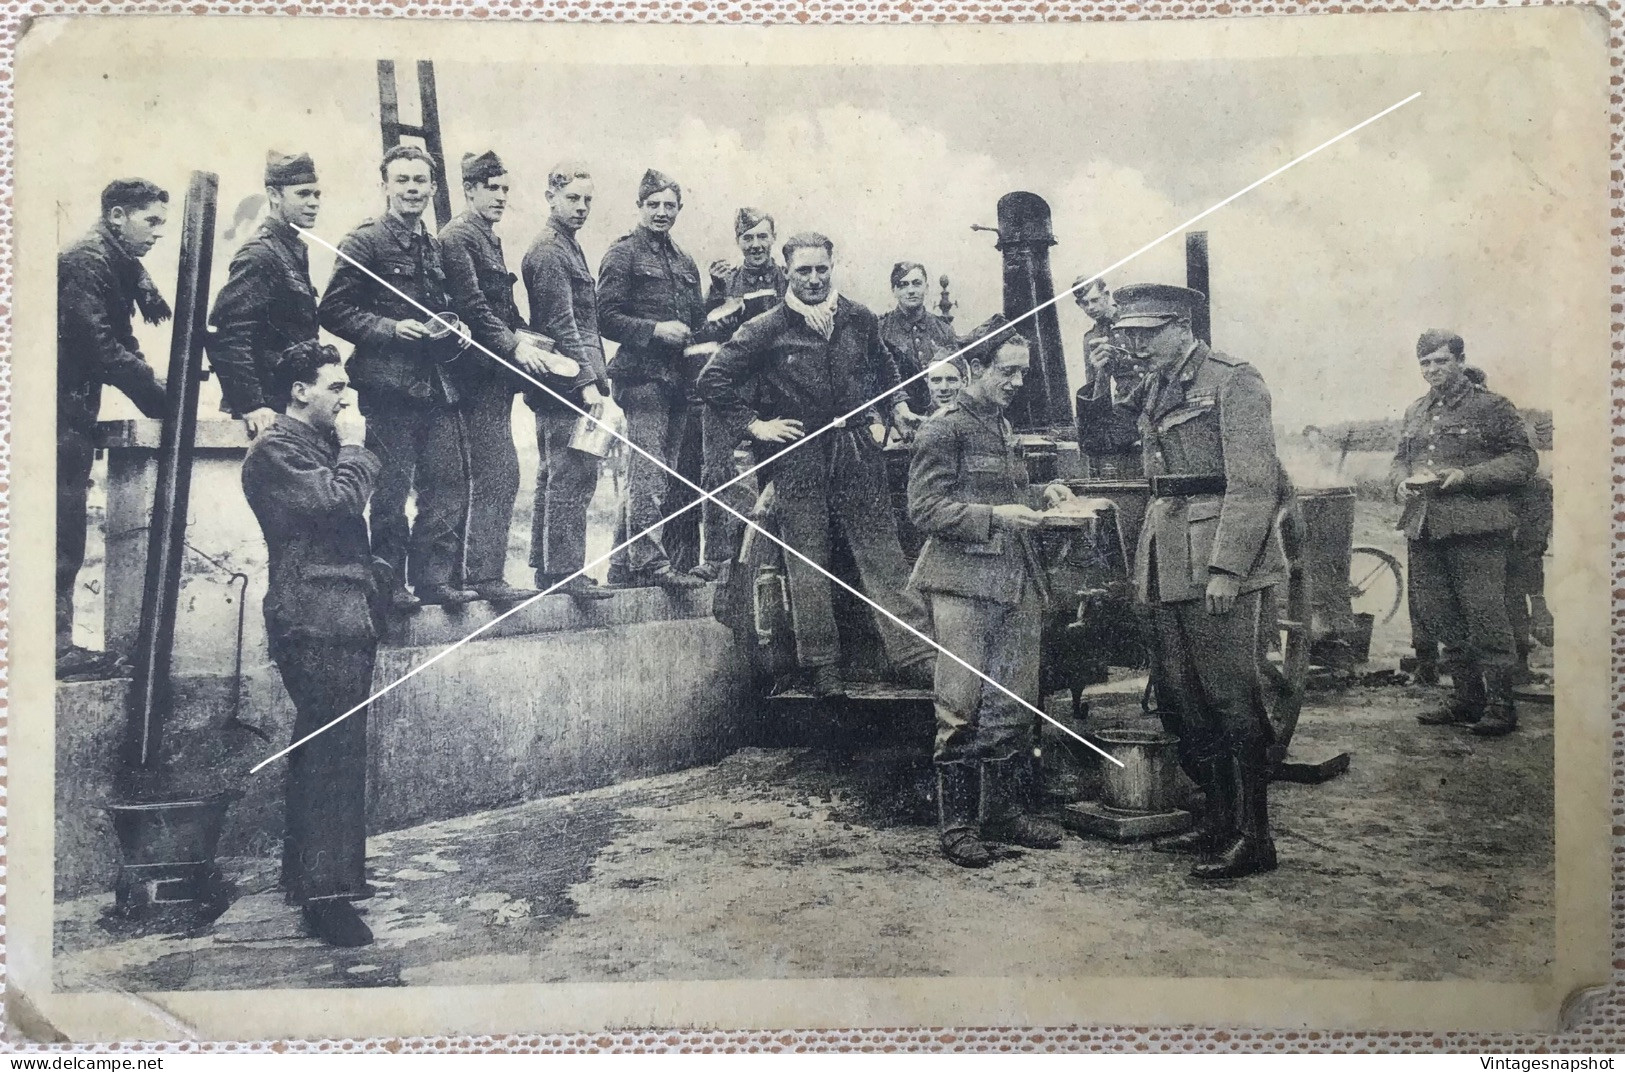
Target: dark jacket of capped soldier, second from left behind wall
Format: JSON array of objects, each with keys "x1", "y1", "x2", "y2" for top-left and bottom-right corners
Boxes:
[{"x1": 208, "y1": 218, "x2": 319, "y2": 417}]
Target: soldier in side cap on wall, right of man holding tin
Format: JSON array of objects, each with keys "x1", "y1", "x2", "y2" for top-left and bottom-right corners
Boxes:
[{"x1": 598, "y1": 169, "x2": 705, "y2": 590}]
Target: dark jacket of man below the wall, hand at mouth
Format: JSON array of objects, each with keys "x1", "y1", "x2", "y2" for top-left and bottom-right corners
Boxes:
[{"x1": 242, "y1": 414, "x2": 382, "y2": 643}]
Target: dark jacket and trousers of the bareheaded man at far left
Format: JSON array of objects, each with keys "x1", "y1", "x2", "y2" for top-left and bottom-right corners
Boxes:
[{"x1": 57, "y1": 224, "x2": 164, "y2": 651}]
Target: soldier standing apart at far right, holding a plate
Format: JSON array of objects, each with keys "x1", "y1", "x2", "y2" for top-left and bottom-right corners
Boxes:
[{"x1": 1389, "y1": 331, "x2": 1539, "y2": 737}]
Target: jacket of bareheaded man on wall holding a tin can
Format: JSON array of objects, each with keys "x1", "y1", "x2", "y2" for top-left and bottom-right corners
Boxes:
[{"x1": 520, "y1": 218, "x2": 609, "y2": 413}]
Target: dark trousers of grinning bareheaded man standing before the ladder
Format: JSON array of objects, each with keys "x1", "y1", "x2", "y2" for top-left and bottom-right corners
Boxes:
[{"x1": 361, "y1": 395, "x2": 468, "y2": 588}]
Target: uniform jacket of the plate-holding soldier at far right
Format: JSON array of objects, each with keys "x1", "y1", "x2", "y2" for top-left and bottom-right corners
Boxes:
[{"x1": 1388, "y1": 382, "x2": 1539, "y2": 539}]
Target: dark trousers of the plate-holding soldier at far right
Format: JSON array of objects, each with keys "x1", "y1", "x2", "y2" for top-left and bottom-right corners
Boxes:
[{"x1": 1409, "y1": 533, "x2": 1518, "y2": 669}]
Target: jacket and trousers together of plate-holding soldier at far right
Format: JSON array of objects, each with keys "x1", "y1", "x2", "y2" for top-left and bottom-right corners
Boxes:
[{"x1": 1389, "y1": 382, "x2": 1539, "y2": 668}]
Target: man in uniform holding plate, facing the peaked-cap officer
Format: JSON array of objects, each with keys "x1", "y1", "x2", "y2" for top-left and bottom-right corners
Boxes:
[{"x1": 908, "y1": 317, "x2": 1069, "y2": 867}]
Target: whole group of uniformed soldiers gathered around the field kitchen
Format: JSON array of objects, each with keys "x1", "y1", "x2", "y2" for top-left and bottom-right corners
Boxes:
[{"x1": 57, "y1": 146, "x2": 1534, "y2": 945}]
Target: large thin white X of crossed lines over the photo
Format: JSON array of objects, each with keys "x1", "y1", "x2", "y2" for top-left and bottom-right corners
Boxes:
[{"x1": 250, "y1": 91, "x2": 1422, "y2": 773}]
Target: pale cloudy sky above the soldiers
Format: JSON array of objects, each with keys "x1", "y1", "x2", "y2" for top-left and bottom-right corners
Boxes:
[{"x1": 31, "y1": 40, "x2": 1604, "y2": 429}]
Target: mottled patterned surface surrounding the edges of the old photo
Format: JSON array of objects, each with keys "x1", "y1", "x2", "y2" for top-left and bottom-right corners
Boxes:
[{"x1": 0, "y1": 0, "x2": 1625, "y2": 1054}]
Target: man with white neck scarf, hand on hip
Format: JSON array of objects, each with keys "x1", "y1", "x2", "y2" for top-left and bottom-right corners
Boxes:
[{"x1": 700, "y1": 232, "x2": 933, "y2": 697}]
